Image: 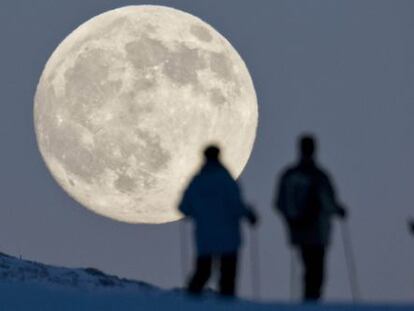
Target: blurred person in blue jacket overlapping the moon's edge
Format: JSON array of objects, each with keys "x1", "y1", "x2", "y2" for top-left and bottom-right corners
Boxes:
[{"x1": 179, "y1": 146, "x2": 256, "y2": 296}]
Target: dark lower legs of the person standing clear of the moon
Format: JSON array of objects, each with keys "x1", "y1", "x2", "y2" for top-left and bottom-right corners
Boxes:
[{"x1": 301, "y1": 246, "x2": 325, "y2": 301}]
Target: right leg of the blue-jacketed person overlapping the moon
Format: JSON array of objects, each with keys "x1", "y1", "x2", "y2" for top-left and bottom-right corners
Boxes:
[{"x1": 219, "y1": 253, "x2": 237, "y2": 296}]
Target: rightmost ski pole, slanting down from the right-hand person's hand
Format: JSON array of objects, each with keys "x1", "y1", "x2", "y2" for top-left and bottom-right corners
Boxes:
[{"x1": 341, "y1": 221, "x2": 360, "y2": 303}]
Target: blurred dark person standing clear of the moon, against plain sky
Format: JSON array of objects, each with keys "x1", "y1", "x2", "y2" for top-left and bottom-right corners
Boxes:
[{"x1": 275, "y1": 136, "x2": 346, "y2": 301}]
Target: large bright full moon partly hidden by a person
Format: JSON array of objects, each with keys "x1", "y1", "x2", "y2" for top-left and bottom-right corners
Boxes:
[{"x1": 34, "y1": 6, "x2": 258, "y2": 223}]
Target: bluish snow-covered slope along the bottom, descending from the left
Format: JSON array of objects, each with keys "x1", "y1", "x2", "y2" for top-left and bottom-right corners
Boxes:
[{"x1": 0, "y1": 253, "x2": 414, "y2": 311}]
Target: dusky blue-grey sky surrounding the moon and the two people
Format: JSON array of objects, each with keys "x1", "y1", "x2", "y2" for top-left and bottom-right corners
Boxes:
[{"x1": 0, "y1": 0, "x2": 414, "y2": 301}]
